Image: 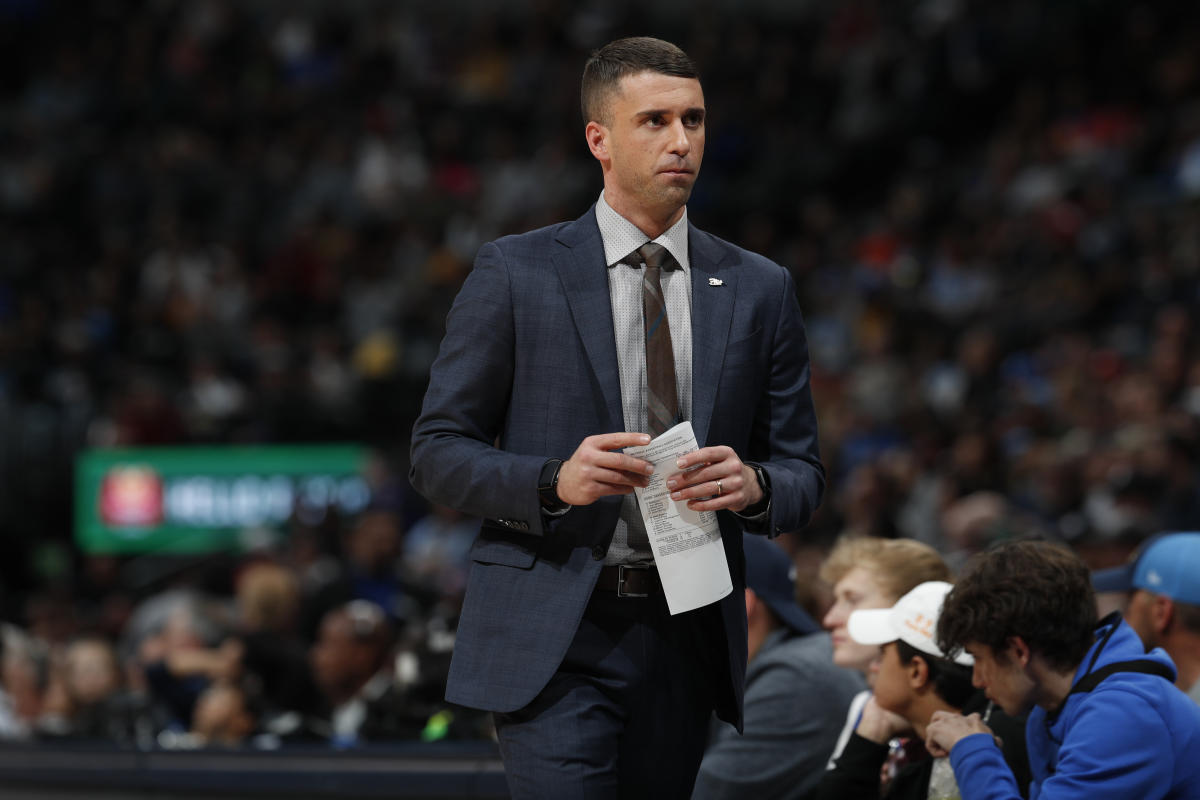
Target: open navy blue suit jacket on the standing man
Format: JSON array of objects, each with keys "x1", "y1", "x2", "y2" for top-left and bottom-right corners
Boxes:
[{"x1": 410, "y1": 209, "x2": 824, "y2": 727}]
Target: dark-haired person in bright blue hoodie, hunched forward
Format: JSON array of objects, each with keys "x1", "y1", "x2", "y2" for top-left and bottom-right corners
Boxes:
[{"x1": 925, "y1": 541, "x2": 1200, "y2": 800}]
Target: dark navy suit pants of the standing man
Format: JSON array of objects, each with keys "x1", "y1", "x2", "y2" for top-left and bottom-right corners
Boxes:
[{"x1": 494, "y1": 590, "x2": 728, "y2": 800}]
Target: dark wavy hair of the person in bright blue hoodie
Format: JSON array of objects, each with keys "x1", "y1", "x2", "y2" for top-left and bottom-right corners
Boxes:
[{"x1": 937, "y1": 541, "x2": 1097, "y2": 669}]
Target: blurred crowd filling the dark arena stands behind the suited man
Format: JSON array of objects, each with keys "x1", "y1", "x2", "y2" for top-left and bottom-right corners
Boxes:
[{"x1": 0, "y1": 0, "x2": 1200, "y2": 744}]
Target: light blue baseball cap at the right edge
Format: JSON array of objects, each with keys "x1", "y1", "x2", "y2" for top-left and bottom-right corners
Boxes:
[{"x1": 1092, "y1": 533, "x2": 1200, "y2": 606}]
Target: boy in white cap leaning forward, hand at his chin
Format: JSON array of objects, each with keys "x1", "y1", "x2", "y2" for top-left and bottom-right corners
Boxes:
[{"x1": 814, "y1": 581, "x2": 1028, "y2": 800}]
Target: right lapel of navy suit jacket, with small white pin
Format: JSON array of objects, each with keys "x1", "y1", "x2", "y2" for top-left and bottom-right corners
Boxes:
[{"x1": 688, "y1": 224, "x2": 738, "y2": 447}]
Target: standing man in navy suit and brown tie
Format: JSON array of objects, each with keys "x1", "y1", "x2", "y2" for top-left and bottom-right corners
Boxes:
[{"x1": 412, "y1": 37, "x2": 824, "y2": 798}]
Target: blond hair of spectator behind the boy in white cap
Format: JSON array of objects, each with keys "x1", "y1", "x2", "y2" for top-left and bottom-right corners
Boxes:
[{"x1": 821, "y1": 536, "x2": 950, "y2": 602}]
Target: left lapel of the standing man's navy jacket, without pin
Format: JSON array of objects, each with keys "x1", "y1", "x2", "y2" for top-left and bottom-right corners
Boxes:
[{"x1": 553, "y1": 206, "x2": 625, "y2": 431}]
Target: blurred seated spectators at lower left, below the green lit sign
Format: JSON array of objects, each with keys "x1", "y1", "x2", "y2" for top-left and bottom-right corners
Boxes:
[{"x1": 0, "y1": 507, "x2": 491, "y2": 748}]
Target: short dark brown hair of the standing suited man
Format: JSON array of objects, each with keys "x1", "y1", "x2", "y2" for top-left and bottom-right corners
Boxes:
[{"x1": 580, "y1": 36, "x2": 700, "y2": 125}]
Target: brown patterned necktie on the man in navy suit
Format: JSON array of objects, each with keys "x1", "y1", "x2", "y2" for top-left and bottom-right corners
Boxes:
[{"x1": 622, "y1": 242, "x2": 679, "y2": 437}]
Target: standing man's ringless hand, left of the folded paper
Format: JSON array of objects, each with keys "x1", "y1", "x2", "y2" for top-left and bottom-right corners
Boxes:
[{"x1": 558, "y1": 433, "x2": 654, "y2": 506}]
